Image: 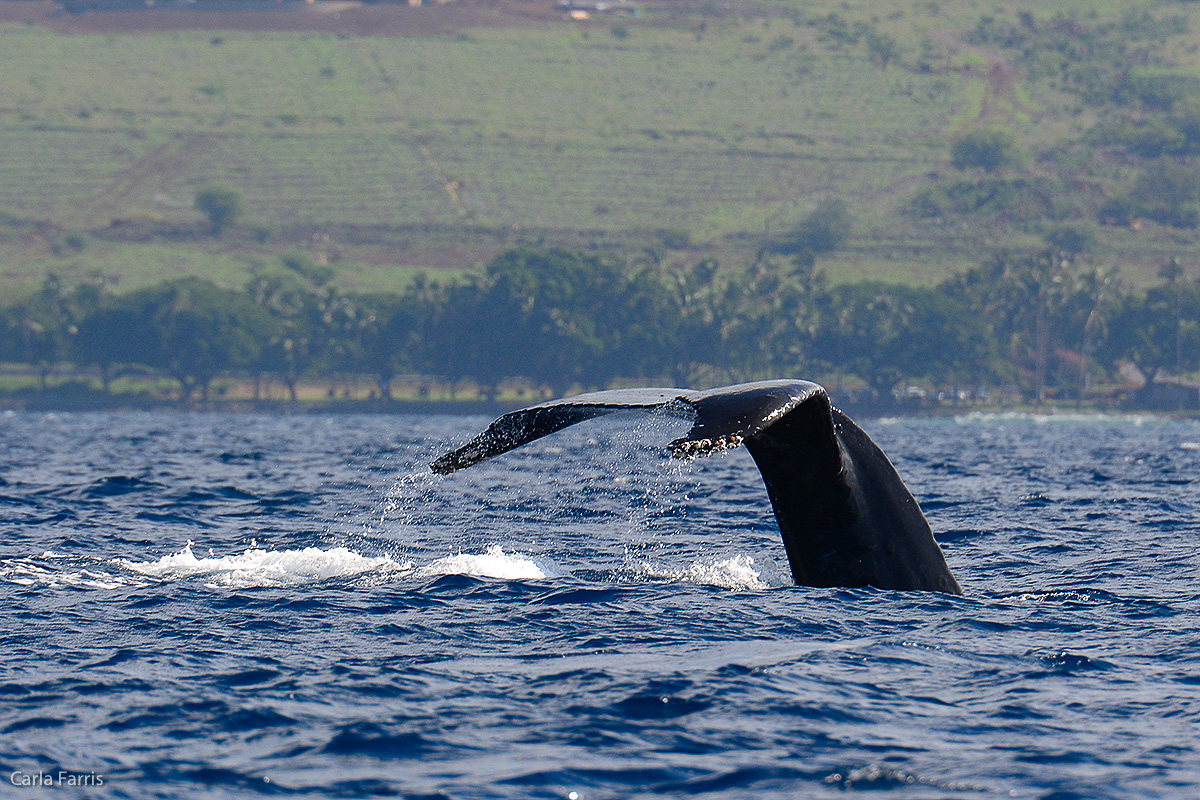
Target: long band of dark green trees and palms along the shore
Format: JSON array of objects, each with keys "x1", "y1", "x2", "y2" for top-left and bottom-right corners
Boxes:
[{"x1": 0, "y1": 247, "x2": 1200, "y2": 401}]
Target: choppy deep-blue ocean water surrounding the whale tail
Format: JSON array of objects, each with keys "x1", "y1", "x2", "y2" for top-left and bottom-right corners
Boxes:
[{"x1": 0, "y1": 413, "x2": 1200, "y2": 800}]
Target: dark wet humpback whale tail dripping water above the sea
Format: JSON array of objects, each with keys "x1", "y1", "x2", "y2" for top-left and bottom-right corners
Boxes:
[{"x1": 431, "y1": 380, "x2": 962, "y2": 595}]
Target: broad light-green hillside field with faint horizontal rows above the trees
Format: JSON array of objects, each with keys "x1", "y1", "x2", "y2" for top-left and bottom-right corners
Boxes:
[{"x1": 0, "y1": 22, "x2": 962, "y2": 235}]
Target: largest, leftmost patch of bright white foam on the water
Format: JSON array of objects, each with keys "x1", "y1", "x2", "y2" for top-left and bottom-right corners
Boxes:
[{"x1": 122, "y1": 542, "x2": 413, "y2": 587}]
